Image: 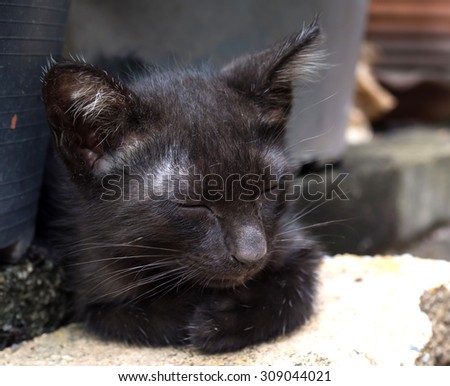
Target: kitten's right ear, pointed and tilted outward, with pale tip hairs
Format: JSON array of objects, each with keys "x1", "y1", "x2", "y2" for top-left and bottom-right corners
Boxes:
[{"x1": 221, "y1": 20, "x2": 322, "y2": 123}]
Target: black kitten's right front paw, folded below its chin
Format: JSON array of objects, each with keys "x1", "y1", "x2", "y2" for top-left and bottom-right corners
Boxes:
[{"x1": 188, "y1": 272, "x2": 312, "y2": 353}]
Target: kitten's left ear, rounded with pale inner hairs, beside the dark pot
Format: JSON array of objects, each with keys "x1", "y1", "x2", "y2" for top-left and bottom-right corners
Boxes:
[{"x1": 42, "y1": 62, "x2": 141, "y2": 179}]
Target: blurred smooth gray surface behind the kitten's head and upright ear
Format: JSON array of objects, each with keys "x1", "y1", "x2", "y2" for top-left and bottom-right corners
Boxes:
[{"x1": 66, "y1": 0, "x2": 367, "y2": 166}]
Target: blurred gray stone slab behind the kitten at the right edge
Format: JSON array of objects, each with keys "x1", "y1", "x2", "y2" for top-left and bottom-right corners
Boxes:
[{"x1": 297, "y1": 127, "x2": 450, "y2": 258}]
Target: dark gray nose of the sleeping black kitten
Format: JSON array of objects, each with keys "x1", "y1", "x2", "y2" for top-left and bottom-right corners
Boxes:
[{"x1": 233, "y1": 225, "x2": 267, "y2": 264}]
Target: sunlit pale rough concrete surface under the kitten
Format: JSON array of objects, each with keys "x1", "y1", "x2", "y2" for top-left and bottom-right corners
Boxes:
[{"x1": 0, "y1": 255, "x2": 450, "y2": 365}]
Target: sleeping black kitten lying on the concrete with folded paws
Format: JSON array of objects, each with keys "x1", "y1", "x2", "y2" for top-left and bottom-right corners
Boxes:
[{"x1": 43, "y1": 23, "x2": 320, "y2": 353}]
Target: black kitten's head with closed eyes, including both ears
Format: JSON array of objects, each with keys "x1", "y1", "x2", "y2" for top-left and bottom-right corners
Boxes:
[{"x1": 43, "y1": 23, "x2": 320, "y2": 292}]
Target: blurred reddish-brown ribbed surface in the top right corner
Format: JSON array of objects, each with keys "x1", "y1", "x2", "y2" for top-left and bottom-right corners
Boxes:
[{"x1": 368, "y1": 0, "x2": 450, "y2": 79}]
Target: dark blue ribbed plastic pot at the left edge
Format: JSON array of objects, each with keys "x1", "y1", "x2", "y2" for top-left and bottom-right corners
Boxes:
[{"x1": 0, "y1": 0, "x2": 69, "y2": 256}]
